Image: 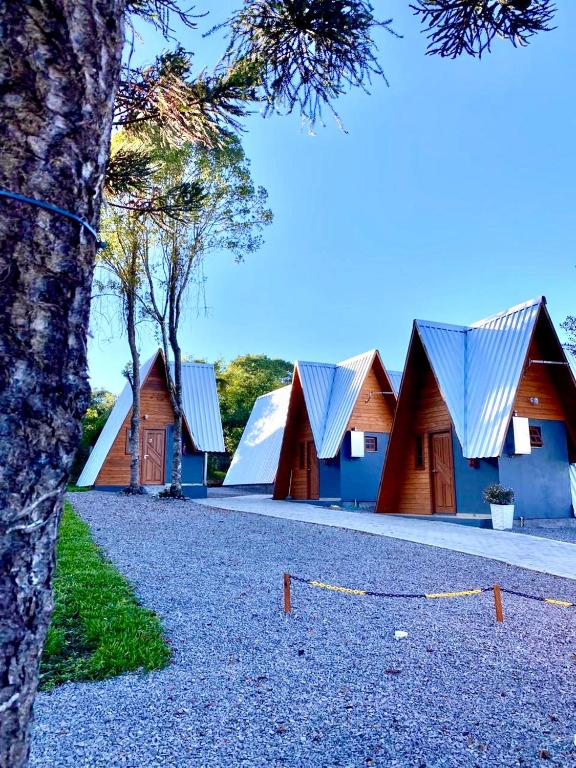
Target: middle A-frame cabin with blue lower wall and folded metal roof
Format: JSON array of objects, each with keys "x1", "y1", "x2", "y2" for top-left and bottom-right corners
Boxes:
[{"x1": 274, "y1": 350, "x2": 399, "y2": 502}]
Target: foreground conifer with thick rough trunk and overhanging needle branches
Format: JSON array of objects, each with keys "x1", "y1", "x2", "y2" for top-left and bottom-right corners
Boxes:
[{"x1": 0, "y1": 0, "x2": 553, "y2": 768}]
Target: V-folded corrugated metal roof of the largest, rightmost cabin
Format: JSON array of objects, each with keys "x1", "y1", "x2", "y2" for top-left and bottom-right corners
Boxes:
[{"x1": 416, "y1": 296, "x2": 546, "y2": 458}]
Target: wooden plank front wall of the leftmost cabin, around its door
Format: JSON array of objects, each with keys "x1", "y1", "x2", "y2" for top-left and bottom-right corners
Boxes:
[{"x1": 95, "y1": 357, "x2": 174, "y2": 486}]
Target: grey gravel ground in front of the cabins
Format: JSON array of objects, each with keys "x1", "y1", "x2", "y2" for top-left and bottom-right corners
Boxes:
[{"x1": 31, "y1": 493, "x2": 576, "y2": 768}]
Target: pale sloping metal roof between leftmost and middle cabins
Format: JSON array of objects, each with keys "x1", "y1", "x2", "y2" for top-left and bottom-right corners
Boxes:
[{"x1": 224, "y1": 386, "x2": 292, "y2": 485}]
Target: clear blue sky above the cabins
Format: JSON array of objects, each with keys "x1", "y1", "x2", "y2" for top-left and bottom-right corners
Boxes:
[{"x1": 89, "y1": 0, "x2": 576, "y2": 391}]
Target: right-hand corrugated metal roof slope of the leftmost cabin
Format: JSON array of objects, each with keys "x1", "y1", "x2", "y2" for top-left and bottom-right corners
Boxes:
[{"x1": 176, "y1": 363, "x2": 226, "y2": 453}]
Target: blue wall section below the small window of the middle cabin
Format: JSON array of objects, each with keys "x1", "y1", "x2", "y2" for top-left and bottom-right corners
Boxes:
[{"x1": 340, "y1": 432, "x2": 390, "y2": 501}]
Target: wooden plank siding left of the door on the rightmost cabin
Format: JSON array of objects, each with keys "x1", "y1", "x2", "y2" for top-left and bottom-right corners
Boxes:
[{"x1": 376, "y1": 332, "x2": 452, "y2": 515}]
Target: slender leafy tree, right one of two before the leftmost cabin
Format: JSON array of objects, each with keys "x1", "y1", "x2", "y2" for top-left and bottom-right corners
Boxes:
[{"x1": 142, "y1": 137, "x2": 272, "y2": 497}]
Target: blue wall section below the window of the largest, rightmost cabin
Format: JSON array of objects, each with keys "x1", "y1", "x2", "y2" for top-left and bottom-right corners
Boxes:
[{"x1": 499, "y1": 419, "x2": 572, "y2": 518}]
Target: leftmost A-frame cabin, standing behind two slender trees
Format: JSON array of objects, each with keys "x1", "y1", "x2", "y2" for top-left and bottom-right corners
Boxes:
[{"x1": 78, "y1": 350, "x2": 224, "y2": 497}]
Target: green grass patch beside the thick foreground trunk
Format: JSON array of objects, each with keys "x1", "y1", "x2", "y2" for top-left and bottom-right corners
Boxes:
[{"x1": 40, "y1": 502, "x2": 171, "y2": 690}]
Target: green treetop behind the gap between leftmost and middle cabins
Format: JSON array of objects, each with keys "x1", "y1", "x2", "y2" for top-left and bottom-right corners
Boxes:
[{"x1": 217, "y1": 355, "x2": 293, "y2": 454}]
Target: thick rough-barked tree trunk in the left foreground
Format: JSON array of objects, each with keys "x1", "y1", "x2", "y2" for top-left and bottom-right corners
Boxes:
[{"x1": 0, "y1": 0, "x2": 124, "y2": 768}]
